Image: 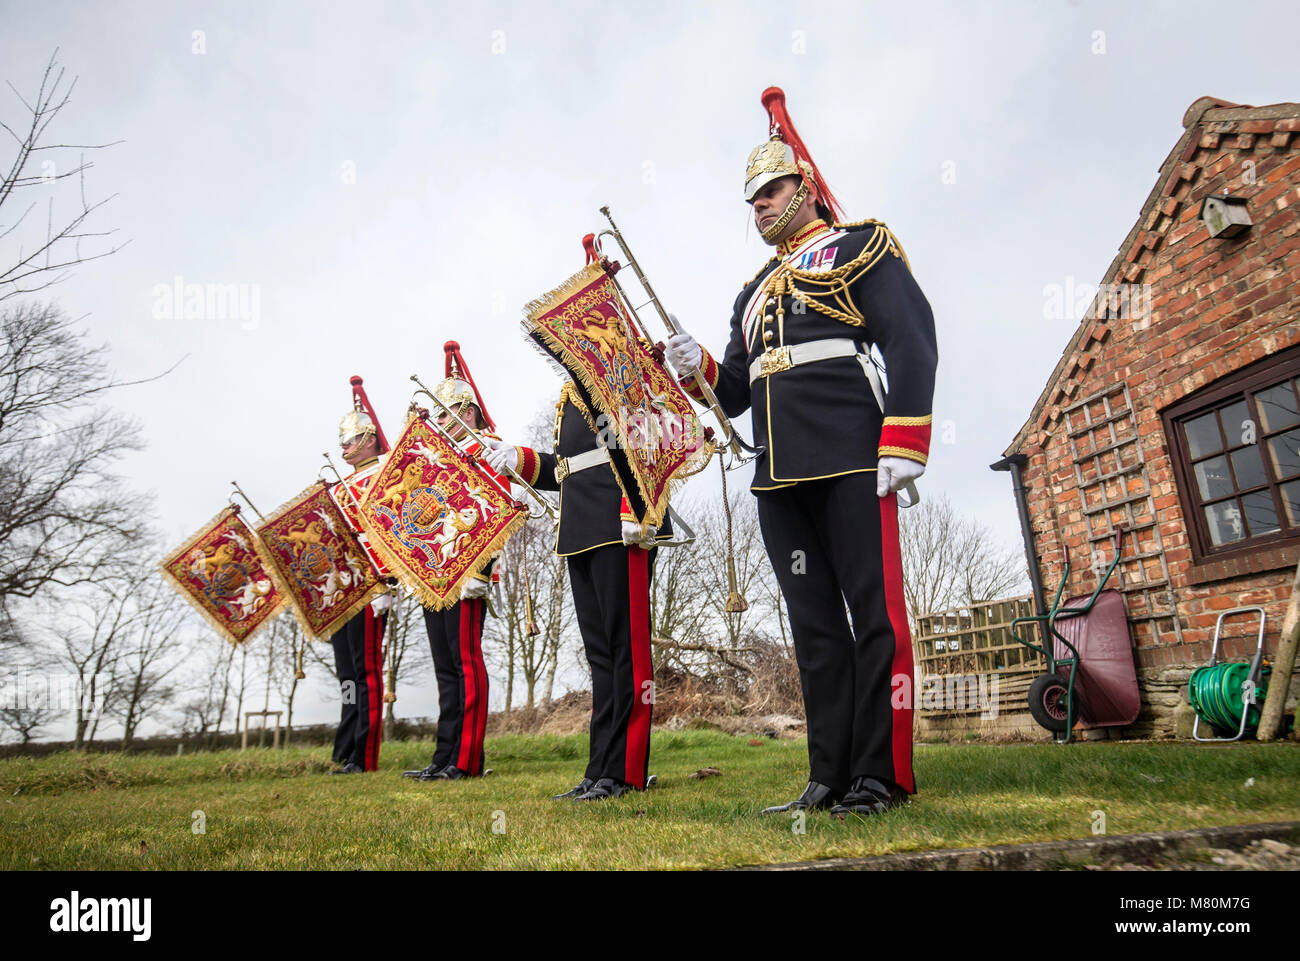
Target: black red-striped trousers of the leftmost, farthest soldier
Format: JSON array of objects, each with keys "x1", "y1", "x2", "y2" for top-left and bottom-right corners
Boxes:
[{"x1": 330, "y1": 605, "x2": 386, "y2": 771}]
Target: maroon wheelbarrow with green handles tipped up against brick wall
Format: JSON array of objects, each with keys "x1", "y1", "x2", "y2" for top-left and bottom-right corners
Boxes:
[{"x1": 1011, "y1": 528, "x2": 1141, "y2": 744}]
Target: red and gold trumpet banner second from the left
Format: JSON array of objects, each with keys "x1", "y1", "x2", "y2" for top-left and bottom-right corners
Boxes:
[{"x1": 257, "y1": 481, "x2": 386, "y2": 641}]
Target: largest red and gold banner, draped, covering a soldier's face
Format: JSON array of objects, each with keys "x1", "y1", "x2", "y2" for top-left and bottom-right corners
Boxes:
[{"x1": 524, "y1": 263, "x2": 714, "y2": 525}]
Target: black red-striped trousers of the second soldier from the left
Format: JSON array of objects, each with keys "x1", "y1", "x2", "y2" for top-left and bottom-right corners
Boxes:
[{"x1": 424, "y1": 598, "x2": 488, "y2": 775}]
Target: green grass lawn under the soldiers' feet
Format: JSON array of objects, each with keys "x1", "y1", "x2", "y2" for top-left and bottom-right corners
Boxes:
[{"x1": 0, "y1": 731, "x2": 1300, "y2": 870}]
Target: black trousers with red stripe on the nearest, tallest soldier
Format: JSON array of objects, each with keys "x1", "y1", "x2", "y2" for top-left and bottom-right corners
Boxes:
[{"x1": 758, "y1": 472, "x2": 917, "y2": 793}]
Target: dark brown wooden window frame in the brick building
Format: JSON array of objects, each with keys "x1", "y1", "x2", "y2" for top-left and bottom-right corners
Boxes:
[{"x1": 1161, "y1": 345, "x2": 1300, "y2": 567}]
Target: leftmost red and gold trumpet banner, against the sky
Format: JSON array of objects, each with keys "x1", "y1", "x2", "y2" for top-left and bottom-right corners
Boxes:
[{"x1": 160, "y1": 506, "x2": 286, "y2": 646}]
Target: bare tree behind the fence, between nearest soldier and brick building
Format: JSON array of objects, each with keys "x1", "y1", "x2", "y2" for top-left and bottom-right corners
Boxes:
[{"x1": 898, "y1": 494, "x2": 1028, "y2": 622}]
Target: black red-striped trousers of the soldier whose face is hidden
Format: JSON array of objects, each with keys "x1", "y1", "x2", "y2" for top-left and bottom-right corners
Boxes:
[{"x1": 568, "y1": 544, "x2": 654, "y2": 788}]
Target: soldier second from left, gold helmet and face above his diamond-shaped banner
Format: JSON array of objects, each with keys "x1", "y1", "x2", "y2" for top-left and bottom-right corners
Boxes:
[{"x1": 403, "y1": 341, "x2": 510, "y2": 780}]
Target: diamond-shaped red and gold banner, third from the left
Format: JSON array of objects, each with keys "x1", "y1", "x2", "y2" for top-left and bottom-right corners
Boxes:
[{"x1": 361, "y1": 416, "x2": 528, "y2": 611}]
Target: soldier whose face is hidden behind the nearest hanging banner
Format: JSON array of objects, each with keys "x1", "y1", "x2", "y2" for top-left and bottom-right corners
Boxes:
[{"x1": 488, "y1": 381, "x2": 671, "y2": 801}]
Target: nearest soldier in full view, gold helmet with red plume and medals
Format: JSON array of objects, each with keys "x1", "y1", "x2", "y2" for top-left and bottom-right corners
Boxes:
[{"x1": 668, "y1": 87, "x2": 937, "y2": 814}]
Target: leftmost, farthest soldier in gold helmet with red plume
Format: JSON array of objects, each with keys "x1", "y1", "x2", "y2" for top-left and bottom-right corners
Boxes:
[{"x1": 330, "y1": 377, "x2": 391, "y2": 774}]
